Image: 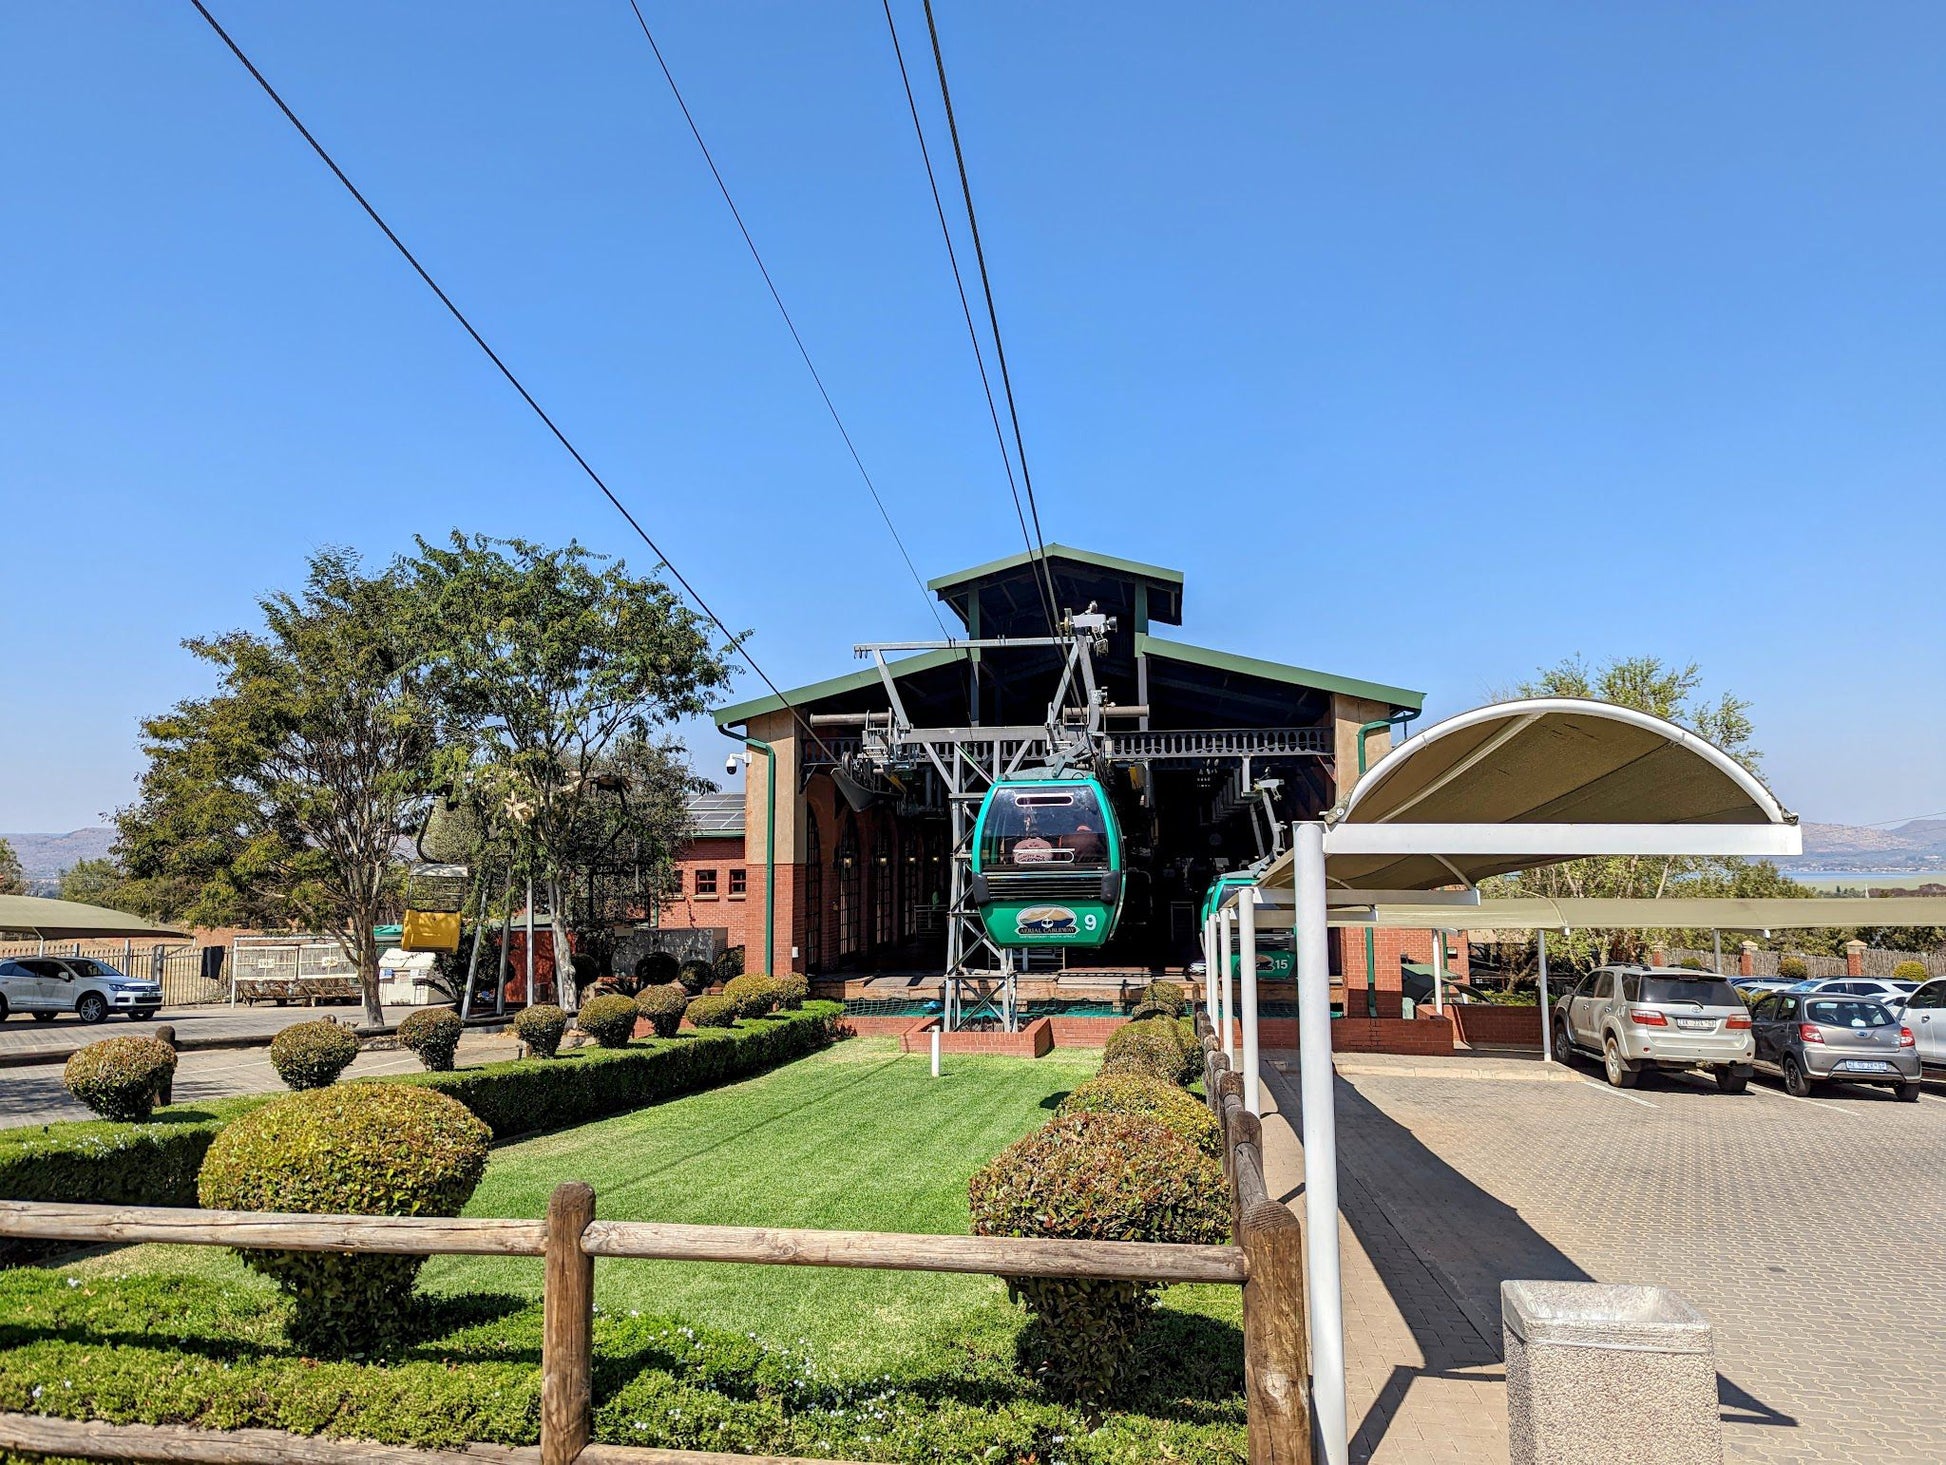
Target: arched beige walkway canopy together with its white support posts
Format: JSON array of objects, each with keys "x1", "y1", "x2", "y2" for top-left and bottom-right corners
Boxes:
[{"x1": 1205, "y1": 697, "x2": 1802, "y2": 1465}]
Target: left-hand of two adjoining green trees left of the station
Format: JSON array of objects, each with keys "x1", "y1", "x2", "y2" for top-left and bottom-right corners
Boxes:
[{"x1": 117, "y1": 549, "x2": 440, "y2": 1025}]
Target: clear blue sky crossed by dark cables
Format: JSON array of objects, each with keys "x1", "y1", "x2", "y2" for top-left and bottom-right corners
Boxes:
[{"x1": 0, "y1": 0, "x2": 1946, "y2": 829}]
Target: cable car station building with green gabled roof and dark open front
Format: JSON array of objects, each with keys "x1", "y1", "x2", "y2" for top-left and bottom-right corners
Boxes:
[{"x1": 714, "y1": 545, "x2": 1430, "y2": 1012}]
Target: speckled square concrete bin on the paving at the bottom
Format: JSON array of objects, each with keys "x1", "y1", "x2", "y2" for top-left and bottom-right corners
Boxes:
[{"x1": 1500, "y1": 1282, "x2": 1722, "y2": 1465}]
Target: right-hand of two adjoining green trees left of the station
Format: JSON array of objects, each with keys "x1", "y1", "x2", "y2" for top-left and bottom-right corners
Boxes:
[{"x1": 403, "y1": 531, "x2": 730, "y2": 1010}]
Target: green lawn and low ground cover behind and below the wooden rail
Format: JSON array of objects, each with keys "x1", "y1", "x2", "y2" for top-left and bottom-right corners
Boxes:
[{"x1": 22, "y1": 1039, "x2": 1242, "y2": 1465}]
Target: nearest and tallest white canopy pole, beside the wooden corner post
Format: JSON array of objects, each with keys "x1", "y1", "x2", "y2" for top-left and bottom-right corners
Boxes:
[{"x1": 1292, "y1": 823, "x2": 1349, "y2": 1465}]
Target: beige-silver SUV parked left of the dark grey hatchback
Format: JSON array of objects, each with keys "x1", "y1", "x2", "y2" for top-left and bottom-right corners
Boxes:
[{"x1": 1553, "y1": 967, "x2": 1757, "y2": 1093}]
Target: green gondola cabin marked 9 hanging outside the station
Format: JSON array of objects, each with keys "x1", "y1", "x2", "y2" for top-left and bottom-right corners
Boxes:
[{"x1": 971, "y1": 774, "x2": 1123, "y2": 947}]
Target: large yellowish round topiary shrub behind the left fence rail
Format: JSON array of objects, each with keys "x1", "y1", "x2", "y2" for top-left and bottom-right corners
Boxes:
[{"x1": 197, "y1": 1084, "x2": 492, "y2": 1356}]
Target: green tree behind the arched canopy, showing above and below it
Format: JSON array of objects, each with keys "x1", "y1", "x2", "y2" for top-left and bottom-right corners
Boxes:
[{"x1": 1485, "y1": 656, "x2": 1806, "y2": 963}]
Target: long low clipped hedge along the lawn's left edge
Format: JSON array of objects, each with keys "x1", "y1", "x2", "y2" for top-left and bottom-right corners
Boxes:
[{"x1": 370, "y1": 1002, "x2": 845, "y2": 1140}]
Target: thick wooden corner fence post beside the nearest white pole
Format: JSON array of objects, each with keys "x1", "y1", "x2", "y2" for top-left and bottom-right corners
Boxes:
[{"x1": 1238, "y1": 1200, "x2": 1312, "y2": 1465}]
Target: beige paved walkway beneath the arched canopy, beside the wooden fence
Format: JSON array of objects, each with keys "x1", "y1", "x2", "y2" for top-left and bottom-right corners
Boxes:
[{"x1": 1263, "y1": 1054, "x2": 1506, "y2": 1465}]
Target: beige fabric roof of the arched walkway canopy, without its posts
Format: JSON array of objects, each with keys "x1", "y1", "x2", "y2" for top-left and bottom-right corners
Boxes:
[{"x1": 1263, "y1": 697, "x2": 1796, "y2": 891}]
